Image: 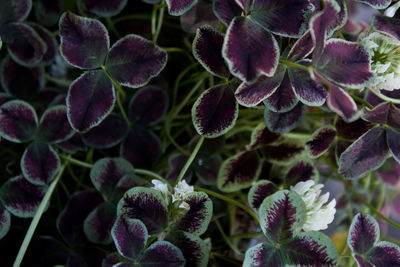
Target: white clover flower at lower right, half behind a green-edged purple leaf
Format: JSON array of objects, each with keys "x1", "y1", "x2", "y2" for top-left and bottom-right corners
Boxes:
[{"x1": 290, "y1": 180, "x2": 336, "y2": 231}]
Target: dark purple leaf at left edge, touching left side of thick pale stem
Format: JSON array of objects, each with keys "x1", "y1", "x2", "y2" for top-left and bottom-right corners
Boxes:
[{"x1": 0, "y1": 175, "x2": 47, "y2": 218}]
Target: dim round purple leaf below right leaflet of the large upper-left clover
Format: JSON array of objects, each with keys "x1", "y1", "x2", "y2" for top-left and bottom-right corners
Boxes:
[{"x1": 128, "y1": 86, "x2": 168, "y2": 126}]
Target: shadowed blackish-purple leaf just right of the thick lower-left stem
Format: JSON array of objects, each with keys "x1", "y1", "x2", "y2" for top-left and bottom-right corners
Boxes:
[{"x1": 57, "y1": 190, "x2": 103, "y2": 245}]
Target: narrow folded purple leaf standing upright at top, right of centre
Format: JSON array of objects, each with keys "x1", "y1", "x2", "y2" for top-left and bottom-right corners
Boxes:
[{"x1": 310, "y1": 0, "x2": 340, "y2": 59}]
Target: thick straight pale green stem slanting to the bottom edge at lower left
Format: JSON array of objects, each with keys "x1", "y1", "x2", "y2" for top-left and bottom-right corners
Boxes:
[{"x1": 13, "y1": 165, "x2": 66, "y2": 267}]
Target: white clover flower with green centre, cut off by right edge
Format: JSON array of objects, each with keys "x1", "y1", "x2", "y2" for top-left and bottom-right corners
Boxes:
[{"x1": 360, "y1": 32, "x2": 400, "y2": 91}]
